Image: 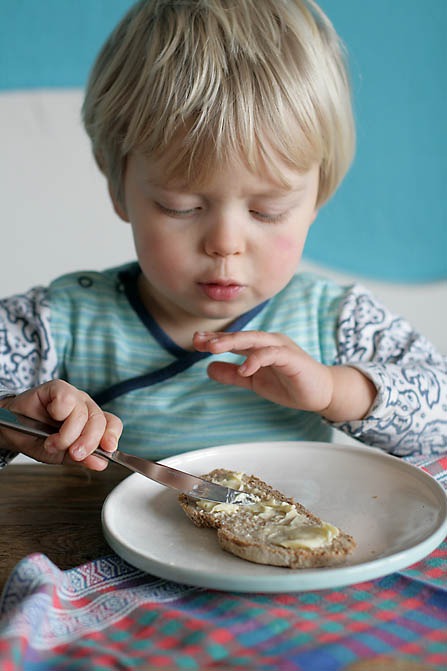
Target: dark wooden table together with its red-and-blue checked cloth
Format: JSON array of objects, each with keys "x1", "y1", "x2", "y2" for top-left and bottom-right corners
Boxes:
[{"x1": 0, "y1": 462, "x2": 447, "y2": 671}]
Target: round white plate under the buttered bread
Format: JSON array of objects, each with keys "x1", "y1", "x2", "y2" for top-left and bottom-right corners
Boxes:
[{"x1": 102, "y1": 442, "x2": 447, "y2": 592}]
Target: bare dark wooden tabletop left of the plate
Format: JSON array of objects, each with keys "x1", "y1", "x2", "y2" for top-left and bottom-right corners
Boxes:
[{"x1": 0, "y1": 464, "x2": 129, "y2": 590}]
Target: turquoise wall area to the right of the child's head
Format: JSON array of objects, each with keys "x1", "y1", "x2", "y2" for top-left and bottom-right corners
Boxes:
[{"x1": 316, "y1": 0, "x2": 447, "y2": 281}]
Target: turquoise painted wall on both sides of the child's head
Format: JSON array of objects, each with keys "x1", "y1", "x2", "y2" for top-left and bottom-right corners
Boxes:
[{"x1": 0, "y1": 0, "x2": 447, "y2": 282}]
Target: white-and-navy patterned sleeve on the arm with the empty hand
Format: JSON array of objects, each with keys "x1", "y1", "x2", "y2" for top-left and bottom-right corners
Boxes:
[{"x1": 335, "y1": 286, "x2": 447, "y2": 456}]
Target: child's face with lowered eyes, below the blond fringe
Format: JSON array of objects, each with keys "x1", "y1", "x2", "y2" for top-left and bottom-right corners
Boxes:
[{"x1": 115, "y1": 153, "x2": 319, "y2": 334}]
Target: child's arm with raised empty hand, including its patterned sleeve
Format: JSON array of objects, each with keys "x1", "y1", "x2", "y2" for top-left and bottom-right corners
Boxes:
[{"x1": 194, "y1": 287, "x2": 447, "y2": 455}]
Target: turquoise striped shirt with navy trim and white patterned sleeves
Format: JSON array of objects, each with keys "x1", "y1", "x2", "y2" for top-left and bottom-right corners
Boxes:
[{"x1": 0, "y1": 263, "x2": 447, "y2": 459}]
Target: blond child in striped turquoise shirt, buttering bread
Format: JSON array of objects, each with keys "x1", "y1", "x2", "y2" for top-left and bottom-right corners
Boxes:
[{"x1": 0, "y1": 0, "x2": 447, "y2": 469}]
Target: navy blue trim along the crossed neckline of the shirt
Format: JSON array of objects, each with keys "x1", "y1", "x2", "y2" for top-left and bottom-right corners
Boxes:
[{"x1": 93, "y1": 264, "x2": 269, "y2": 406}]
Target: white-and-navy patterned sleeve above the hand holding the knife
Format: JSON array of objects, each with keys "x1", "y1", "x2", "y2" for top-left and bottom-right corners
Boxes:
[{"x1": 0, "y1": 287, "x2": 57, "y2": 468}]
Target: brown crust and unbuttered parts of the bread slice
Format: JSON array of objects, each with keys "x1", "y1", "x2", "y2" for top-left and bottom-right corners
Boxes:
[{"x1": 179, "y1": 468, "x2": 355, "y2": 569}]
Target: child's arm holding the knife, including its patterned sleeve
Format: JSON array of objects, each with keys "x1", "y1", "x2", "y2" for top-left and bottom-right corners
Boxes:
[{"x1": 0, "y1": 288, "x2": 122, "y2": 470}]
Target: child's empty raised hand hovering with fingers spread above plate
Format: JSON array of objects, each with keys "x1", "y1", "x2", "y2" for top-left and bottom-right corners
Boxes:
[{"x1": 193, "y1": 331, "x2": 376, "y2": 421}]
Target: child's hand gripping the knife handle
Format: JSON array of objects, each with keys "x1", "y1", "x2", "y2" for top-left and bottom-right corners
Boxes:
[{"x1": 0, "y1": 380, "x2": 123, "y2": 471}]
